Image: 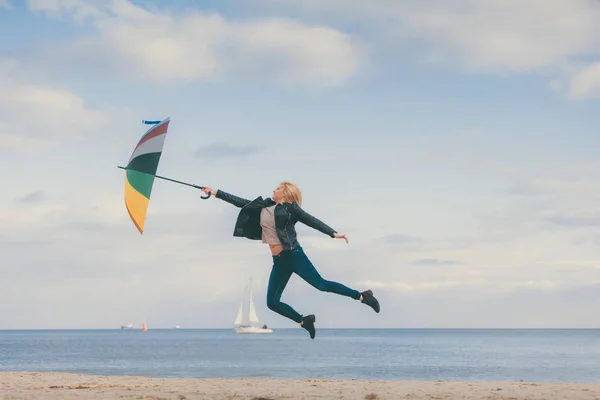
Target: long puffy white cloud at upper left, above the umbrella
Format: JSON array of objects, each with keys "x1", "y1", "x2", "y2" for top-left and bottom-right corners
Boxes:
[{"x1": 29, "y1": 0, "x2": 362, "y2": 88}]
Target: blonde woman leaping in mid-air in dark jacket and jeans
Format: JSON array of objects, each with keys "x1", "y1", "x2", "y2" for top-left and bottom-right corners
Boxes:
[{"x1": 202, "y1": 182, "x2": 379, "y2": 339}]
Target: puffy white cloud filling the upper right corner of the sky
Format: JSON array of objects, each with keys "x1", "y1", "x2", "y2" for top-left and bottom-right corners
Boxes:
[{"x1": 400, "y1": 0, "x2": 600, "y2": 72}]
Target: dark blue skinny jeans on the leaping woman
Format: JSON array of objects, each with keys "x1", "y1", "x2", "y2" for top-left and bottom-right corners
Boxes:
[{"x1": 267, "y1": 247, "x2": 360, "y2": 323}]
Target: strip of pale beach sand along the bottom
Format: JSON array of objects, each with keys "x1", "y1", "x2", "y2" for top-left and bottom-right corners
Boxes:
[{"x1": 0, "y1": 372, "x2": 600, "y2": 400}]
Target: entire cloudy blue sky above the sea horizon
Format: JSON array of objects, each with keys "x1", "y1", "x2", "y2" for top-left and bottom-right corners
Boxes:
[{"x1": 0, "y1": 0, "x2": 600, "y2": 329}]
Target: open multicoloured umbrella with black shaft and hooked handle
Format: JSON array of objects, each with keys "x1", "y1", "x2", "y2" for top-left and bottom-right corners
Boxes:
[{"x1": 119, "y1": 118, "x2": 210, "y2": 234}]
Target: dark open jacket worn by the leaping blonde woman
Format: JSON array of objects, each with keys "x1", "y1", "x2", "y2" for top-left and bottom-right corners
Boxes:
[{"x1": 215, "y1": 190, "x2": 336, "y2": 250}]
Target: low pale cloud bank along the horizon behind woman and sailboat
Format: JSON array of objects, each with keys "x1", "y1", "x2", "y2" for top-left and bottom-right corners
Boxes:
[{"x1": 0, "y1": 183, "x2": 600, "y2": 328}]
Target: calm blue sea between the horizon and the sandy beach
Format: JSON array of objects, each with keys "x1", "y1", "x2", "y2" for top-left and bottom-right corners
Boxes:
[{"x1": 0, "y1": 329, "x2": 600, "y2": 382}]
